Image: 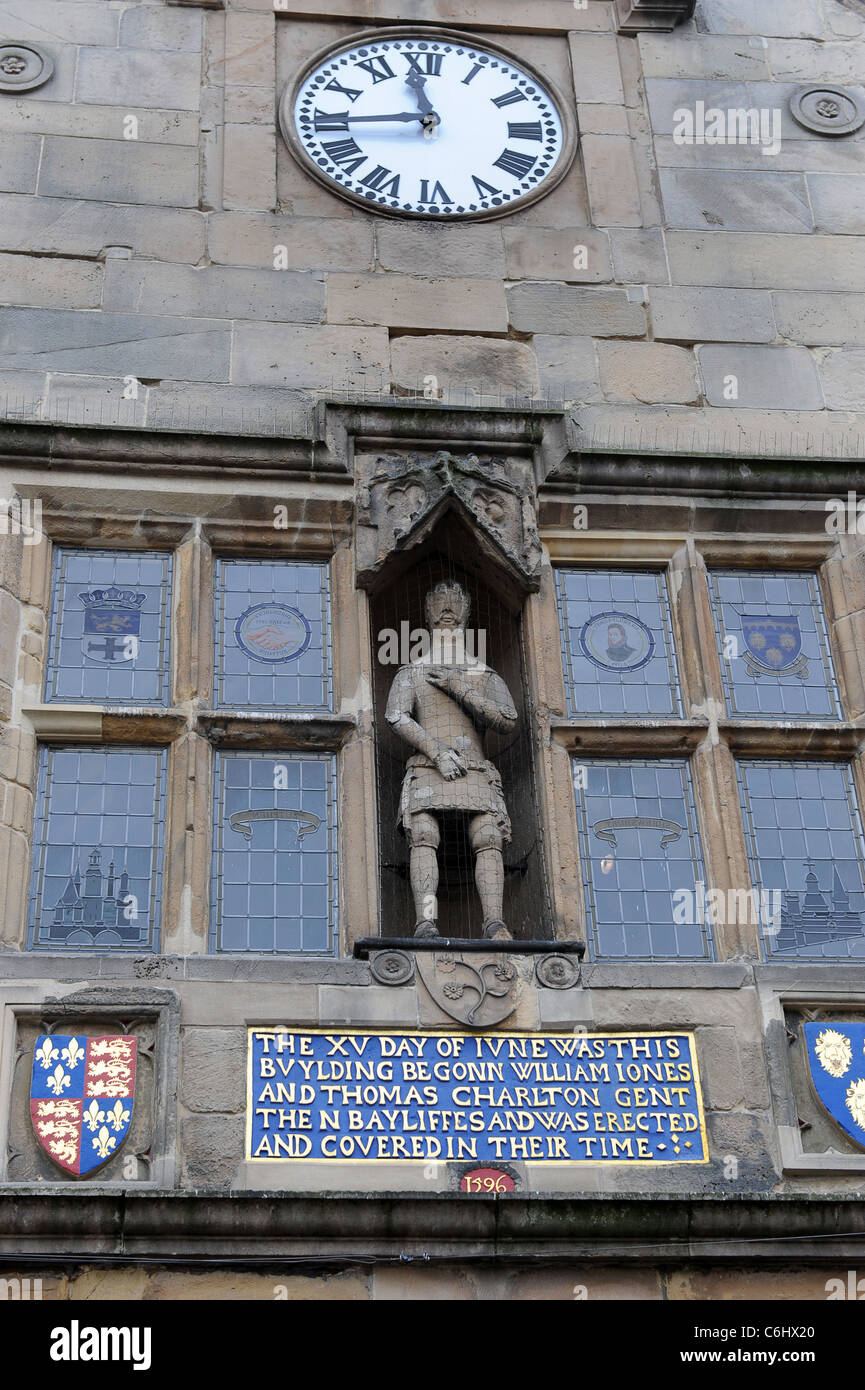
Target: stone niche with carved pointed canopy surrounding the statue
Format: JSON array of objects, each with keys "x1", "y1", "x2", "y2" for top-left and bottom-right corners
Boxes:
[{"x1": 356, "y1": 453, "x2": 552, "y2": 940}]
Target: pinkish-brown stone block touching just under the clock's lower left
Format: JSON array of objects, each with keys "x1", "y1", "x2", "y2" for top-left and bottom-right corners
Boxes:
[{"x1": 207, "y1": 213, "x2": 373, "y2": 271}]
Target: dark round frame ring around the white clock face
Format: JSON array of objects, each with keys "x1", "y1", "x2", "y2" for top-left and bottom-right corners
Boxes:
[{"x1": 280, "y1": 24, "x2": 580, "y2": 225}]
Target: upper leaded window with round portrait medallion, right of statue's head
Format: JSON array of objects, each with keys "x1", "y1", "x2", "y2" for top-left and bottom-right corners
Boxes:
[{"x1": 556, "y1": 570, "x2": 681, "y2": 719}]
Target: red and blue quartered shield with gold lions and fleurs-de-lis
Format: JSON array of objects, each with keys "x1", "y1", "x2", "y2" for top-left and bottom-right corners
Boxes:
[{"x1": 31, "y1": 1034, "x2": 136, "y2": 1177}]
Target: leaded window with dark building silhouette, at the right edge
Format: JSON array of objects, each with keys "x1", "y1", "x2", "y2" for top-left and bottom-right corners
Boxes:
[{"x1": 738, "y1": 759, "x2": 865, "y2": 960}]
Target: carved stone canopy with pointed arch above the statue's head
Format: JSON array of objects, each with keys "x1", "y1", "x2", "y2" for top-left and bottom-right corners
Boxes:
[{"x1": 356, "y1": 450, "x2": 541, "y2": 589}]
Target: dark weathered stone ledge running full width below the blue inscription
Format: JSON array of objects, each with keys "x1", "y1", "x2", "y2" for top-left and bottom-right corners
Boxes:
[{"x1": 0, "y1": 1183, "x2": 865, "y2": 1268}]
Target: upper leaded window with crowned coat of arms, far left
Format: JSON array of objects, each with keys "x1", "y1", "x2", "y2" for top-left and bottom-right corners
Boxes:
[{"x1": 45, "y1": 546, "x2": 171, "y2": 705}]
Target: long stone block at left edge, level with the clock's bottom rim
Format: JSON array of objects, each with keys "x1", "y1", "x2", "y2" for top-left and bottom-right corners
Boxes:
[{"x1": 0, "y1": 195, "x2": 204, "y2": 264}]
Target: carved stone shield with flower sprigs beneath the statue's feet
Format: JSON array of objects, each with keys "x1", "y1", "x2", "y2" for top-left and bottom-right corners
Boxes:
[{"x1": 416, "y1": 951, "x2": 520, "y2": 1029}]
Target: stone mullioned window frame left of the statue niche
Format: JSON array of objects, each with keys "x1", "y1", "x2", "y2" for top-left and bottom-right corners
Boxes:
[{"x1": 10, "y1": 505, "x2": 375, "y2": 963}]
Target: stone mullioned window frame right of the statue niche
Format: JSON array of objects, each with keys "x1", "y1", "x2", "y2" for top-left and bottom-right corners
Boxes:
[{"x1": 533, "y1": 525, "x2": 865, "y2": 970}]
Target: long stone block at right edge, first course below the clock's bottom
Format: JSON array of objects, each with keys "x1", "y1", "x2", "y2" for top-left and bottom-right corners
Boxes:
[{"x1": 666, "y1": 231, "x2": 865, "y2": 291}]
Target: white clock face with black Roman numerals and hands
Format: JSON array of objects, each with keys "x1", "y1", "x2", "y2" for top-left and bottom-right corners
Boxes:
[{"x1": 281, "y1": 28, "x2": 574, "y2": 221}]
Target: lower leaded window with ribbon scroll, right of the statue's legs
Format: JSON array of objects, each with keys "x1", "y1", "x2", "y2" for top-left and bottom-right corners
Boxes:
[{"x1": 574, "y1": 759, "x2": 711, "y2": 960}]
